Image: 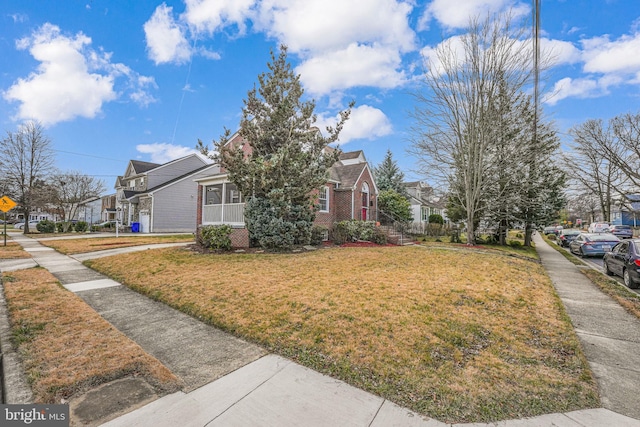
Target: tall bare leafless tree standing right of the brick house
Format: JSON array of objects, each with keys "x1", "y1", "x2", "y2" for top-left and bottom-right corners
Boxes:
[{"x1": 409, "y1": 15, "x2": 532, "y2": 244}]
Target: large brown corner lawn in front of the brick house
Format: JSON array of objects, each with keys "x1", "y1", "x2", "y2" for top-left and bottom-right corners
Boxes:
[{"x1": 88, "y1": 247, "x2": 599, "y2": 422}]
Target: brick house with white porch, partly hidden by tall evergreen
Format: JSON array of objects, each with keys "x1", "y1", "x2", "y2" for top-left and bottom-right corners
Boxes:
[{"x1": 196, "y1": 133, "x2": 378, "y2": 247}]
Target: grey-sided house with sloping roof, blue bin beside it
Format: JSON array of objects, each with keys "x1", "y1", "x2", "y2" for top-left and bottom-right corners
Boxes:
[{"x1": 115, "y1": 154, "x2": 219, "y2": 233}]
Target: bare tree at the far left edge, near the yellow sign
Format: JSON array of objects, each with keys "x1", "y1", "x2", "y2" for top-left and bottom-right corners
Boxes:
[{"x1": 0, "y1": 122, "x2": 54, "y2": 233}]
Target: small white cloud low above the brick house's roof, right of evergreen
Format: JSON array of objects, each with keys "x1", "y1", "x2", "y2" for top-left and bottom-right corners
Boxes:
[{"x1": 317, "y1": 105, "x2": 393, "y2": 144}]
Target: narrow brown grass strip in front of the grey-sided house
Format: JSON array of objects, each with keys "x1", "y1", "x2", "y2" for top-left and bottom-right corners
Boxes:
[{"x1": 40, "y1": 234, "x2": 194, "y2": 255}]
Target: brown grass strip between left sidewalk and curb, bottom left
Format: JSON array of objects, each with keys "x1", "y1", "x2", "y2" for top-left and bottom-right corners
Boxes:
[{"x1": 3, "y1": 268, "x2": 178, "y2": 403}]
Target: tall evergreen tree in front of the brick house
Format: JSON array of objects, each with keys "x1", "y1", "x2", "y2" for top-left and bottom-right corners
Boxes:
[{"x1": 198, "y1": 45, "x2": 353, "y2": 249}]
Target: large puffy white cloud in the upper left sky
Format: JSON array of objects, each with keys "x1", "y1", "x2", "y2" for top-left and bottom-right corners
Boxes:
[{"x1": 3, "y1": 23, "x2": 155, "y2": 125}]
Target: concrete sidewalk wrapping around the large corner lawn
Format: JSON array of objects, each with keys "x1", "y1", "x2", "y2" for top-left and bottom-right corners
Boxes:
[{"x1": 0, "y1": 234, "x2": 640, "y2": 427}]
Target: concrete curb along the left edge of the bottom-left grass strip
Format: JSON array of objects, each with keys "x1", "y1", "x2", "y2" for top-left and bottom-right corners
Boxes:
[{"x1": 0, "y1": 275, "x2": 33, "y2": 404}]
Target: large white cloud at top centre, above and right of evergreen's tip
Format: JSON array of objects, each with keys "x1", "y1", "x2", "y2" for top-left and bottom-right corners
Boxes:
[{"x1": 256, "y1": 0, "x2": 416, "y2": 97}]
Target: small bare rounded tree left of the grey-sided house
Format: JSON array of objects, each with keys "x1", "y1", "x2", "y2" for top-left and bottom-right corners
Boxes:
[{"x1": 49, "y1": 171, "x2": 105, "y2": 232}]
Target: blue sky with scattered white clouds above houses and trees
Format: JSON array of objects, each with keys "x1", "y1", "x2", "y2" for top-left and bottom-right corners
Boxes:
[{"x1": 0, "y1": 0, "x2": 640, "y2": 194}]
